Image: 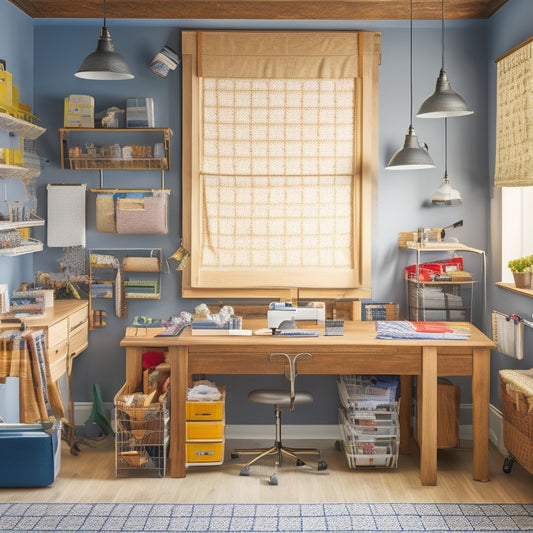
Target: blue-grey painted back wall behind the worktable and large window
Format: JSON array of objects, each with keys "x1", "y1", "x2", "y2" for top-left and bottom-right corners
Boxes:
[{"x1": 0, "y1": 0, "x2": 533, "y2": 424}]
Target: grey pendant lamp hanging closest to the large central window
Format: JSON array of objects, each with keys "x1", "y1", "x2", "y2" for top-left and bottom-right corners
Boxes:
[{"x1": 385, "y1": 0, "x2": 435, "y2": 170}]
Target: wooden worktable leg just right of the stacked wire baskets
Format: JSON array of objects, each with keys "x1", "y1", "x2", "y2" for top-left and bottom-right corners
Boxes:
[{"x1": 417, "y1": 346, "x2": 437, "y2": 485}]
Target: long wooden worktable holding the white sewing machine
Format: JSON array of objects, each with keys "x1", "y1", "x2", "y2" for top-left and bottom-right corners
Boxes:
[{"x1": 121, "y1": 321, "x2": 494, "y2": 485}]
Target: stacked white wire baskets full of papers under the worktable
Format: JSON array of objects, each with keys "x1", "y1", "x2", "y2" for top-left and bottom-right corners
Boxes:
[{"x1": 337, "y1": 376, "x2": 400, "y2": 469}]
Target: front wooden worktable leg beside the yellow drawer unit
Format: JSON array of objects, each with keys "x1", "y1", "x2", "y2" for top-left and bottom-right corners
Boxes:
[{"x1": 168, "y1": 346, "x2": 189, "y2": 477}]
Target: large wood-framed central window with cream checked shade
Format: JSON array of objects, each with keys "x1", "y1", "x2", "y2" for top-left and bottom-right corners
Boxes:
[{"x1": 182, "y1": 31, "x2": 380, "y2": 298}]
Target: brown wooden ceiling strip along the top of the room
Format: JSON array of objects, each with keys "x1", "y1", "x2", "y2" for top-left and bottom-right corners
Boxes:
[{"x1": 6, "y1": 0, "x2": 509, "y2": 20}]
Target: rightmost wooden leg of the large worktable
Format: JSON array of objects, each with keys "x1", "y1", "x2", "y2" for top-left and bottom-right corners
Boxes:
[{"x1": 472, "y1": 348, "x2": 490, "y2": 481}]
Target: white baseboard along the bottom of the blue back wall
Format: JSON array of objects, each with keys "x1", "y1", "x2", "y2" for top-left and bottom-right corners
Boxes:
[{"x1": 74, "y1": 402, "x2": 507, "y2": 448}]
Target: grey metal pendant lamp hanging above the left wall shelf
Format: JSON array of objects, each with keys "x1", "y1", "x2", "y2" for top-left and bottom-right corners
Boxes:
[{"x1": 74, "y1": 0, "x2": 135, "y2": 80}]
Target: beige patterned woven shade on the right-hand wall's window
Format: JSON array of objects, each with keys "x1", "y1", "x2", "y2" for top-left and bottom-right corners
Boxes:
[{"x1": 494, "y1": 38, "x2": 533, "y2": 187}]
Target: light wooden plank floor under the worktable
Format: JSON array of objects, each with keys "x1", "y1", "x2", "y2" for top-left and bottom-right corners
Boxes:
[{"x1": 0, "y1": 437, "x2": 533, "y2": 503}]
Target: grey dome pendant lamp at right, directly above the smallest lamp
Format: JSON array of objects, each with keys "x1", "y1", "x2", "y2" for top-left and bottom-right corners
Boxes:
[{"x1": 416, "y1": 0, "x2": 473, "y2": 118}]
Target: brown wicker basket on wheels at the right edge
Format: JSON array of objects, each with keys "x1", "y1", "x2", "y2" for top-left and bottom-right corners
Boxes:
[{"x1": 500, "y1": 370, "x2": 533, "y2": 474}]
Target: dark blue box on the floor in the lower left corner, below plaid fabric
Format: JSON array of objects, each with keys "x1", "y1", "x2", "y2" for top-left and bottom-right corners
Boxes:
[{"x1": 0, "y1": 422, "x2": 61, "y2": 487}]
